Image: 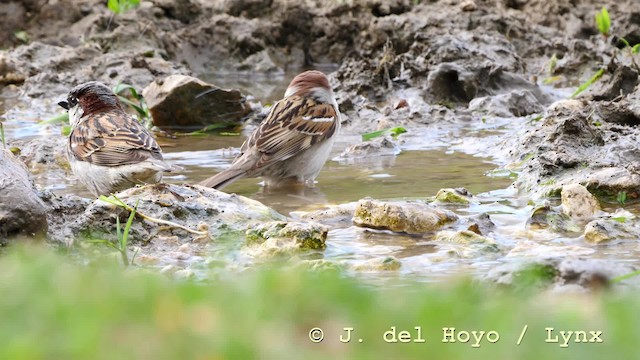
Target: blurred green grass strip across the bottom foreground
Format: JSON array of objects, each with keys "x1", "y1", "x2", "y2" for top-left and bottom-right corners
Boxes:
[{"x1": 0, "y1": 243, "x2": 640, "y2": 359}]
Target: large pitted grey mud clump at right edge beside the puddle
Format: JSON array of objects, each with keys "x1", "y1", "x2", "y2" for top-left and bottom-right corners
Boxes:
[{"x1": 507, "y1": 93, "x2": 640, "y2": 197}]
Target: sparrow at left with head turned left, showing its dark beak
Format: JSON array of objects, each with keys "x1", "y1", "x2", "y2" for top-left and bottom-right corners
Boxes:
[{"x1": 58, "y1": 81, "x2": 174, "y2": 197}]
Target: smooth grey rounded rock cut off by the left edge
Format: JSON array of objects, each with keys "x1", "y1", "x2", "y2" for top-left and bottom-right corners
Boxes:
[{"x1": 0, "y1": 148, "x2": 48, "y2": 243}]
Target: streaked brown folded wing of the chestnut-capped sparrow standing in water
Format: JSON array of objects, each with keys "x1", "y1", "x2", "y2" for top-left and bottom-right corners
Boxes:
[{"x1": 241, "y1": 96, "x2": 340, "y2": 168}]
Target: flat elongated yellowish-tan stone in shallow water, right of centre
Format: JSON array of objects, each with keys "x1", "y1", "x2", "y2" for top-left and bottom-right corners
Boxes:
[{"x1": 353, "y1": 198, "x2": 458, "y2": 234}]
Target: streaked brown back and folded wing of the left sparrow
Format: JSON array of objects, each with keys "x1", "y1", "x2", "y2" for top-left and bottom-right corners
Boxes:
[{"x1": 69, "y1": 112, "x2": 162, "y2": 166}]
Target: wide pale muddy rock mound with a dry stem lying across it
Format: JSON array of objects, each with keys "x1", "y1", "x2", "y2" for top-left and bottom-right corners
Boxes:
[{"x1": 51, "y1": 184, "x2": 284, "y2": 246}]
